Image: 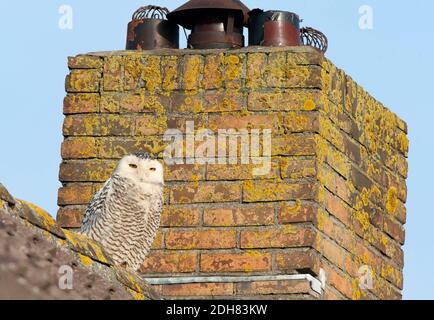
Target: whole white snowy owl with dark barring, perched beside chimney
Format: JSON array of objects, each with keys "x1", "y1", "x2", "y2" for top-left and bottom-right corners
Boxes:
[{"x1": 81, "y1": 153, "x2": 164, "y2": 271}]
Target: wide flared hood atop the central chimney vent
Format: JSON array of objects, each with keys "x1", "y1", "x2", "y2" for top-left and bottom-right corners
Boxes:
[{"x1": 167, "y1": 0, "x2": 250, "y2": 30}]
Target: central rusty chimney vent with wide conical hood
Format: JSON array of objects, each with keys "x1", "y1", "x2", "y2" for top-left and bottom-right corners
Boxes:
[{"x1": 167, "y1": 0, "x2": 249, "y2": 49}]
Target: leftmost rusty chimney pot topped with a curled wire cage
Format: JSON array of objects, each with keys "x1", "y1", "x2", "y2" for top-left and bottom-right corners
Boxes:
[{"x1": 126, "y1": 5, "x2": 179, "y2": 50}]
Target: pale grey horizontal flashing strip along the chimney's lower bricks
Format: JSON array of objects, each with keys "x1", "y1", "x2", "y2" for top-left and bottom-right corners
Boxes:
[{"x1": 144, "y1": 274, "x2": 323, "y2": 294}]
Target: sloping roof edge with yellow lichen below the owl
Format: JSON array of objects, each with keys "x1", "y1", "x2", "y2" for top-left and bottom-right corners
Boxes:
[{"x1": 0, "y1": 183, "x2": 161, "y2": 300}]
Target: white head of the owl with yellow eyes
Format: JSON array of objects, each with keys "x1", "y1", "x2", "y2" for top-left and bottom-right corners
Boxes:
[{"x1": 114, "y1": 153, "x2": 164, "y2": 186}]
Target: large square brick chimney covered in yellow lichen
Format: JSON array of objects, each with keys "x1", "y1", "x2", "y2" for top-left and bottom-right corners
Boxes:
[{"x1": 57, "y1": 47, "x2": 409, "y2": 299}]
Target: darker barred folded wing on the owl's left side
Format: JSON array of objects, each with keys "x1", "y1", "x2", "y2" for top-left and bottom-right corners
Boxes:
[{"x1": 80, "y1": 179, "x2": 112, "y2": 236}]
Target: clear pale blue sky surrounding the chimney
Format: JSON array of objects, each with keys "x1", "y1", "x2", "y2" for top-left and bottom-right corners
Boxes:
[{"x1": 0, "y1": 0, "x2": 434, "y2": 299}]
